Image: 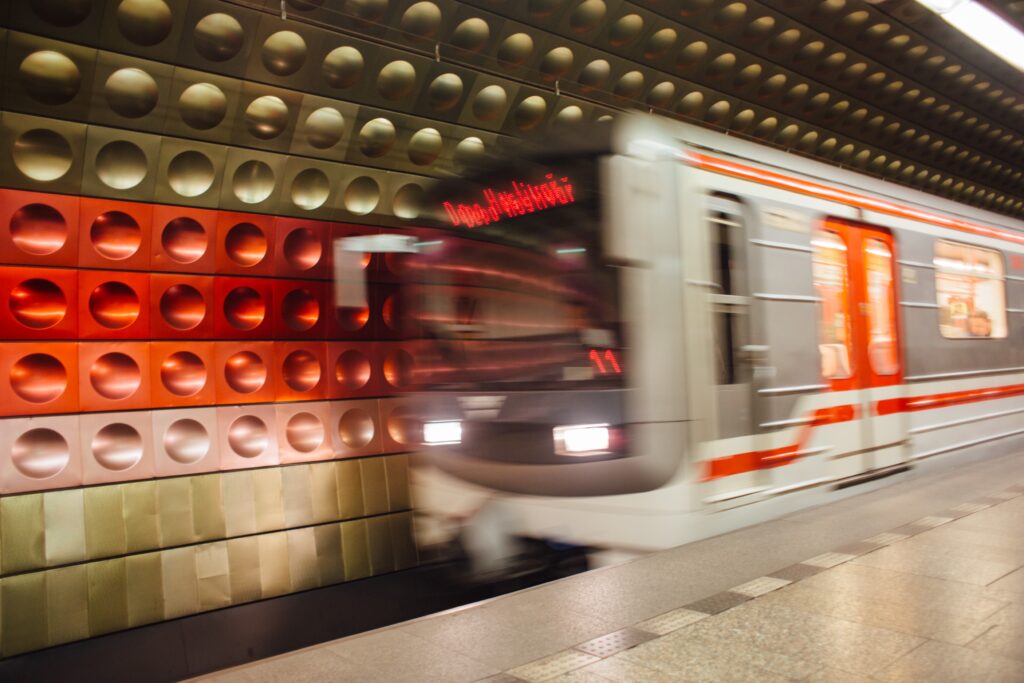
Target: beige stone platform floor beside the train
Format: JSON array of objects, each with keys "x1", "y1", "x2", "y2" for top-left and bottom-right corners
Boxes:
[{"x1": 199, "y1": 448, "x2": 1024, "y2": 683}]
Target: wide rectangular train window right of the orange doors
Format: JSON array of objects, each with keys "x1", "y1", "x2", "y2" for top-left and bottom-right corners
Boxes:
[{"x1": 932, "y1": 240, "x2": 1007, "y2": 339}]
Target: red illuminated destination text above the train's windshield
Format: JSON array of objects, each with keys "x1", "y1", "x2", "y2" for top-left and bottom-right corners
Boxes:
[{"x1": 441, "y1": 173, "x2": 575, "y2": 227}]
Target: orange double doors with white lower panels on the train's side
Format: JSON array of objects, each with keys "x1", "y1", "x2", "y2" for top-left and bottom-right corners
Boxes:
[{"x1": 811, "y1": 219, "x2": 906, "y2": 474}]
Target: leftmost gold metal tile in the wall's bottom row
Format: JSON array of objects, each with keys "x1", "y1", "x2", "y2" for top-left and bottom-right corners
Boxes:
[{"x1": 0, "y1": 571, "x2": 48, "y2": 656}]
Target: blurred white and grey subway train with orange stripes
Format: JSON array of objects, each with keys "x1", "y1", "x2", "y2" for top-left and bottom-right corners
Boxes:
[{"x1": 389, "y1": 116, "x2": 1024, "y2": 550}]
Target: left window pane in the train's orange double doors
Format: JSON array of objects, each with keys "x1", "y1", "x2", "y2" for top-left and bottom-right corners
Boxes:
[{"x1": 811, "y1": 230, "x2": 853, "y2": 380}]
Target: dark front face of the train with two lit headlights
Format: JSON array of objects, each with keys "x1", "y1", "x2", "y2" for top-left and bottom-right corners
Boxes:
[{"x1": 407, "y1": 124, "x2": 683, "y2": 524}]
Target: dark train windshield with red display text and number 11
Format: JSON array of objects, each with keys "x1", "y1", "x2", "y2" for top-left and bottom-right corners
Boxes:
[{"x1": 409, "y1": 156, "x2": 627, "y2": 389}]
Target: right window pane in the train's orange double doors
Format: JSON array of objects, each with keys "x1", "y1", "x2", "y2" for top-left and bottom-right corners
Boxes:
[{"x1": 864, "y1": 238, "x2": 899, "y2": 375}]
